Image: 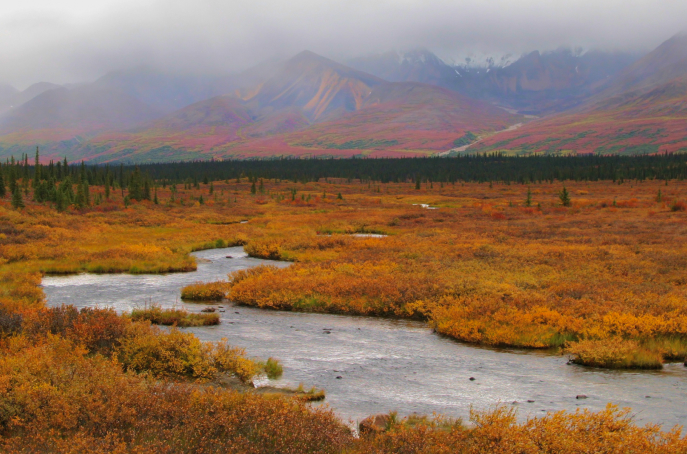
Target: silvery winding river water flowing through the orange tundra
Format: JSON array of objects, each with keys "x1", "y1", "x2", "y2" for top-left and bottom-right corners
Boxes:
[{"x1": 43, "y1": 248, "x2": 687, "y2": 429}]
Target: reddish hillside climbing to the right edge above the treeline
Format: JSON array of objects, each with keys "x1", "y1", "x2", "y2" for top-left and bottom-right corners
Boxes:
[{"x1": 467, "y1": 35, "x2": 687, "y2": 154}]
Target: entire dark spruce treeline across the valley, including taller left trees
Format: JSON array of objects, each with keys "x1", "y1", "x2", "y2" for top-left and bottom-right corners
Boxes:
[{"x1": 0, "y1": 150, "x2": 687, "y2": 199}]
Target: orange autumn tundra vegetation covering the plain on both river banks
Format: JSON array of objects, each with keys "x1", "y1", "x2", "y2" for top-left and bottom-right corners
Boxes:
[{"x1": 0, "y1": 158, "x2": 687, "y2": 453}]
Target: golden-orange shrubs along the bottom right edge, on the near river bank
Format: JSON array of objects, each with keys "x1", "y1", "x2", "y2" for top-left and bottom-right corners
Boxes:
[{"x1": 350, "y1": 404, "x2": 687, "y2": 454}]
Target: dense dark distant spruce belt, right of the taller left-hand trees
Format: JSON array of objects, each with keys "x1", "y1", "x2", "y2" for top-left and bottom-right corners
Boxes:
[{"x1": 105, "y1": 154, "x2": 687, "y2": 184}]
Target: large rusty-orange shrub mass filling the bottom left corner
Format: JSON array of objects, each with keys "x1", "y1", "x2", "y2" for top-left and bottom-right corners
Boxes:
[{"x1": 0, "y1": 336, "x2": 353, "y2": 454}]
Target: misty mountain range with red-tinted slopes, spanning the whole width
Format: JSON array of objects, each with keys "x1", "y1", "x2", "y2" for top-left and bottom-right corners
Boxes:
[{"x1": 0, "y1": 35, "x2": 687, "y2": 162}]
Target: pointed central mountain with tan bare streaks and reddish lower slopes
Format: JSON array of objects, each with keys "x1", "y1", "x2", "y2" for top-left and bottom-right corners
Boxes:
[{"x1": 78, "y1": 52, "x2": 519, "y2": 162}]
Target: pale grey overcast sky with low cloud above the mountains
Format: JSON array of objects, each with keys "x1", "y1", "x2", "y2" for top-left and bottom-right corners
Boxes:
[{"x1": 0, "y1": 0, "x2": 687, "y2": 89}]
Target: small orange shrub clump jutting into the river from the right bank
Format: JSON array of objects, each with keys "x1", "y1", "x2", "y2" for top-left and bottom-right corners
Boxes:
[{"x1": 564, "y1": 338, "x2": 663, "y2": 369}]
